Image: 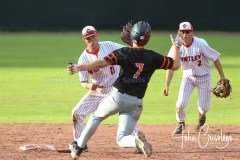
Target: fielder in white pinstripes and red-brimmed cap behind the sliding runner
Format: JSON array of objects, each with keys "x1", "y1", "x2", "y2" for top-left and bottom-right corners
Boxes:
[{"x1": 72, "y1": 26, "x2": 138, "y2": 150}]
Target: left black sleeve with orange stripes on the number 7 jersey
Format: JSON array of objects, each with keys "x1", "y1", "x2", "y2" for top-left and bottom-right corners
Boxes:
[{"x1": 104, "y1": 48, "x2": 126, "y2": 65}]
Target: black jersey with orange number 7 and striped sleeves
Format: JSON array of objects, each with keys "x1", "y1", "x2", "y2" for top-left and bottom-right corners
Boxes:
[{"x1": 104, "y1": 47, "x2": 173, "y2": 98}]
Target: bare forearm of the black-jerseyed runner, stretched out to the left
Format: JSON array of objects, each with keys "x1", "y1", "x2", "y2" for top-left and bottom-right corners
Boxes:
[{"x1": 77, "y1": 59, "x2": 110, "y2": 71}]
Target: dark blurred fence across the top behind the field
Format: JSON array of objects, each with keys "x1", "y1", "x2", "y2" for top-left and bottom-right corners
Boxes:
[{"x1": 0, "y1": 0, "x2": 240, "y2": 31}]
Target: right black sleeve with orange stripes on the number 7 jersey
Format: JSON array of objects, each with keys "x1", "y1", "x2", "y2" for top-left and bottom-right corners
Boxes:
[{"x1": 154, "y1": 54, "x2": 173, "y2": 70}]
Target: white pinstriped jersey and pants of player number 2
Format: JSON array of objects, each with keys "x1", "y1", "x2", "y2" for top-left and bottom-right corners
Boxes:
[{"x1": 169, "y1": 37, "x2": 220, "y2": 122}]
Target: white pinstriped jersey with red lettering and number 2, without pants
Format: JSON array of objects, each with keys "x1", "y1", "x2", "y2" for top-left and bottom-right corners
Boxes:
[{"x1": 168, "y1": 37, "x2": 220, "y2": 76}]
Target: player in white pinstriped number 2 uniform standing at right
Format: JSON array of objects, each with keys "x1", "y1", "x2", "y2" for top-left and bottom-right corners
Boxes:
[{"x1": 163, "y1": 22, "x2": 225, "y2": 134}]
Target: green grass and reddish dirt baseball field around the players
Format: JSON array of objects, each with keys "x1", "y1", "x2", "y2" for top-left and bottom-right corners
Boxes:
[{"x1": 0, "y1": 31, "x2": 240, "y2": 160}]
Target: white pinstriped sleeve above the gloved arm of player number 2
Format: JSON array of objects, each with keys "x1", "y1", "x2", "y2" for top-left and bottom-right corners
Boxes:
[{"x1": 202, "y1": 40, "x2": 221, "y2": 62}]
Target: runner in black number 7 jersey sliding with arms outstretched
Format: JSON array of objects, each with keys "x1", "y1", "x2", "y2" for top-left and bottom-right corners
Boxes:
[{"x1": 68, "y1": 21, "x2": 180, "y2": 159}]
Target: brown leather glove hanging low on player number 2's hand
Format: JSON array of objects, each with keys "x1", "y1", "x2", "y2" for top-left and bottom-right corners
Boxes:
[{"x1": 213, "y1": 79, "x2": 232, "y2": 98}]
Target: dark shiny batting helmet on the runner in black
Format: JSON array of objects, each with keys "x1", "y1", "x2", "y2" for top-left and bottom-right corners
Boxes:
[{"x1": 131, "y1": 21, "x2": 151, "y2": 46}]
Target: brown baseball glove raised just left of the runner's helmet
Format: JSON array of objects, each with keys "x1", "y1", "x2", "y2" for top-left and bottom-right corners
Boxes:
[{"x1": 120, "y1": 22, "x2": 133, "y2": 46}]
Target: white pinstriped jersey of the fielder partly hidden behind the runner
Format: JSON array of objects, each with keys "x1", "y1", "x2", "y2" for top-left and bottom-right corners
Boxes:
[{"x1": 78, "y1": 41, "x2": 125, "y2": 87}]
